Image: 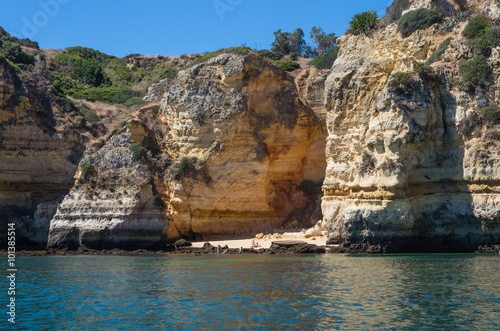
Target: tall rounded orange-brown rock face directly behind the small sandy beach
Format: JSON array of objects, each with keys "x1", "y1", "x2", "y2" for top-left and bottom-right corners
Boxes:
[{"x1": 161, "y1": 54, "x2": 325, "y2": 239}]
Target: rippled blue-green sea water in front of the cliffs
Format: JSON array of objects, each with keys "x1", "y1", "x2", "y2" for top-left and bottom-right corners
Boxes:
[{"x1": 1, "y1": 254, "x2": 500, "y2": 330}]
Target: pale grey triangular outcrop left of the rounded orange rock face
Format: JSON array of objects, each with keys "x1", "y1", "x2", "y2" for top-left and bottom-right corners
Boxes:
[{"x1": 48, "y1": 133, "x2": 168, "y2": 249}]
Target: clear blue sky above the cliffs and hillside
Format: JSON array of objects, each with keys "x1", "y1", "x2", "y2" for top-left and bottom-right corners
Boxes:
[{"x1": 0, "y1": 0, "x2": 392, "y2": 57}]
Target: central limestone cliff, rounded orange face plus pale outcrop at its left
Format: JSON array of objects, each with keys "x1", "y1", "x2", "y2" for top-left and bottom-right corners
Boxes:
[{"x1": 49, "y1": 54, "x2": 326, "y2": 248}]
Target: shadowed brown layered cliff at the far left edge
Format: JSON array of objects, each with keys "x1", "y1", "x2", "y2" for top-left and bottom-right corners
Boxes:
[{"x1": 0, "y1": 59, "x2": 83, "y2": 247}]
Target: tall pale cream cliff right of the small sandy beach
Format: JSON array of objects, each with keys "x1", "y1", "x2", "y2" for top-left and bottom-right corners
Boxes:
[{"x1": 322, "y1": 1, "x2": 500, "y2": 251}]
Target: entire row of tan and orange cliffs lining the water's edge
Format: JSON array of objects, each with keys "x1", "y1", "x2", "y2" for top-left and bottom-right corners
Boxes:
[{"x1": 0, "y1": 0, "x2": 500, "y2": 252}]
